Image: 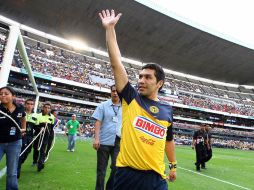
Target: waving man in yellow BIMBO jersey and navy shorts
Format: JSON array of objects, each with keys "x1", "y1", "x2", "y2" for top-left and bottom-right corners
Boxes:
[{"x1": 99, "y1": 10, "x2": 176, "y2": 190}]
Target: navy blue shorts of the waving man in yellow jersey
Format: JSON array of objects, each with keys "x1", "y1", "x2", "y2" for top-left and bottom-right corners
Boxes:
[{"x1": 114, "y1": 167, "x2": 168, "y2": 190}]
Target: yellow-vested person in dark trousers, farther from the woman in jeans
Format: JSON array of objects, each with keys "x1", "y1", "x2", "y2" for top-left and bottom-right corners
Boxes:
[{"x1": 37, "y1": 103, "x2": 54, "y2": 172}]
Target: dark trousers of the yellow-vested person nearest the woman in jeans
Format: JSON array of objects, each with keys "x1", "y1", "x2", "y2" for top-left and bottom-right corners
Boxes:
[{"x1": 17, "y1": 135, "x2": 33, "y2": 178}]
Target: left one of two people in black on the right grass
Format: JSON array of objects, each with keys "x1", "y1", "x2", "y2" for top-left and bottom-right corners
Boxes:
[{"x1": 192, "y1": 125, "x2": 206, "y2": 172}]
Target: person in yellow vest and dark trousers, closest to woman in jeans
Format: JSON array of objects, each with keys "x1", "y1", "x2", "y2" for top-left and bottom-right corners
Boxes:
[{"x1": 17, "y1": 99, "x2": 37, "y2": 178}]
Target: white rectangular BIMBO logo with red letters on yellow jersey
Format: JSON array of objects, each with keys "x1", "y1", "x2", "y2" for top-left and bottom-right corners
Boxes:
[{"x1": 133, "y1": 116, "x2": 167, "y2": 139}]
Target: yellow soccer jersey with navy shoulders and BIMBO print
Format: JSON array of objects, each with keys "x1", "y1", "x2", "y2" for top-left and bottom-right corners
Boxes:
[{"x1": 116, "y1": 83, "x2": 173, "y2": 178}]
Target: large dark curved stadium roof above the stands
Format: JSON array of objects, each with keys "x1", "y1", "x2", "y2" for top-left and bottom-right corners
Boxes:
[{"x1": 0, "y1": 0, "x2": 254, "y2": 85}]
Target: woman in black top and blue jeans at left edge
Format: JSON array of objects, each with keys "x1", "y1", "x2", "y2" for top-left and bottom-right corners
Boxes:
[{"x1": 0, "y1": 87, "x2": 26, "y2": 190}]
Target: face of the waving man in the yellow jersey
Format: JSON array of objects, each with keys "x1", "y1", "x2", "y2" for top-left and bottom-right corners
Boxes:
[{"x1": 138, "y1": 69, "x2": 162, "y2": 97}]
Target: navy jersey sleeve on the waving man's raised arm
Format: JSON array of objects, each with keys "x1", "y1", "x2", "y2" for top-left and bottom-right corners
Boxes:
[{"x1": 118, "y1": 82, "x2": 138, "y2": 104}]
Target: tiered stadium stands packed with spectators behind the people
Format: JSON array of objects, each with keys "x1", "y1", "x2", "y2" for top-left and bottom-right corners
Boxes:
[{"x1": 0, "y1": 25, "x2": 254, "y2": 150}]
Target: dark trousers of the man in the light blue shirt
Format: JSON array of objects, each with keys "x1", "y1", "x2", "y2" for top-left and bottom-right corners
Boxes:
[{"x1": 95, "y1": 137, "x2": 120, "y2": 190}]
